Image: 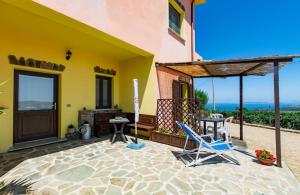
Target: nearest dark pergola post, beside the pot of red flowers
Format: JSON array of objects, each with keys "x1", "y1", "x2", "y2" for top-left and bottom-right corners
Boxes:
[{"x1": 274, "y1": 61, "x2": 281, "y2": 167}]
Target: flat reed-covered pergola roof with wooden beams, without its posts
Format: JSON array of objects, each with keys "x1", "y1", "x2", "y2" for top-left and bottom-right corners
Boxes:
[{"x1": 156, "y1": 55, "x2": 300, "y2": 78}]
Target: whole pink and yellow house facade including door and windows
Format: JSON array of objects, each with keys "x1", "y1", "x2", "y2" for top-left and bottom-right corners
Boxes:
[{"x1": 0, "y1": 0, "x2": 204, "y2": 152}]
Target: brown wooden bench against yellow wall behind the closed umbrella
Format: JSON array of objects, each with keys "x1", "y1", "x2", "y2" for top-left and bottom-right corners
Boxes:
[{"x1": 127, "y1": 114, "x2": 156, "y2": 139}]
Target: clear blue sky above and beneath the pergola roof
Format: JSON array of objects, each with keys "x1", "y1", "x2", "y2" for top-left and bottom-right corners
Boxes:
[{"x1": 195, "y1": 0, "x2": 300, "y2": 103}]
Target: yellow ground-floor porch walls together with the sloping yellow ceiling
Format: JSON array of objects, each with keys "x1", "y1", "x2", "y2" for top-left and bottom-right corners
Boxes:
[{"x1": 0, "y1": 1, "x2": 158, "y2": 152}]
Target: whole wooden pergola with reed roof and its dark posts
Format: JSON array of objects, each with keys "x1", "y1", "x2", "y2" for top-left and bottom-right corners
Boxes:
[{"x1": 156, "y1": 55, "x2": 300, "y2": 167}]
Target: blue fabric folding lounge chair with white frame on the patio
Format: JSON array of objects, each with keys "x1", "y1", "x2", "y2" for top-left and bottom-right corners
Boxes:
[{"x1": 176, "y1": 121, "x2": 240, "y2": 167}]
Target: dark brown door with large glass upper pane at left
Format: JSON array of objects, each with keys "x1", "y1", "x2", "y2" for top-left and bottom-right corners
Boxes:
[{"x1": 14, "y1": 71, "x2": 58, "y2": 142}]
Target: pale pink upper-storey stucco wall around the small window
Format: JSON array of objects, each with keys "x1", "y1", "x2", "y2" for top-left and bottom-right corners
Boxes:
[{"x1": 35, "y1": 0, "x2": 196, "y2": 62}]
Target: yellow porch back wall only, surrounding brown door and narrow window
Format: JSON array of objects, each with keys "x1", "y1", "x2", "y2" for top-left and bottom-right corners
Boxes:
[{"x1": 0, "y1": 34, "x2": 120, "y2": 151}]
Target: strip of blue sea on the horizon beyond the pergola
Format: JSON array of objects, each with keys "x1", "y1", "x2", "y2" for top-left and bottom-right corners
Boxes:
[{"x1": 206, "y1": 102, "x2": 300, "y2": 111}]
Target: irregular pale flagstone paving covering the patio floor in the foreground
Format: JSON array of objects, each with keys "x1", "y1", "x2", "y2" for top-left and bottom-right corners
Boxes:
[{"x1": 0, "y1": 136, "x2": 300, "y2": 195}]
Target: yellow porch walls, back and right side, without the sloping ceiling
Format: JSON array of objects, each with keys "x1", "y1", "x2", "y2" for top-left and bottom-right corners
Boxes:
[{"x1": 0, "y1": 33, "x2": 157, "y2": 152}]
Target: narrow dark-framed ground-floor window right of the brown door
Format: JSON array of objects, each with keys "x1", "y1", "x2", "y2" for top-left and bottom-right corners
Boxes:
[{"x1": 96, "y1": 76, "x2": 112, "y2": 109}]
